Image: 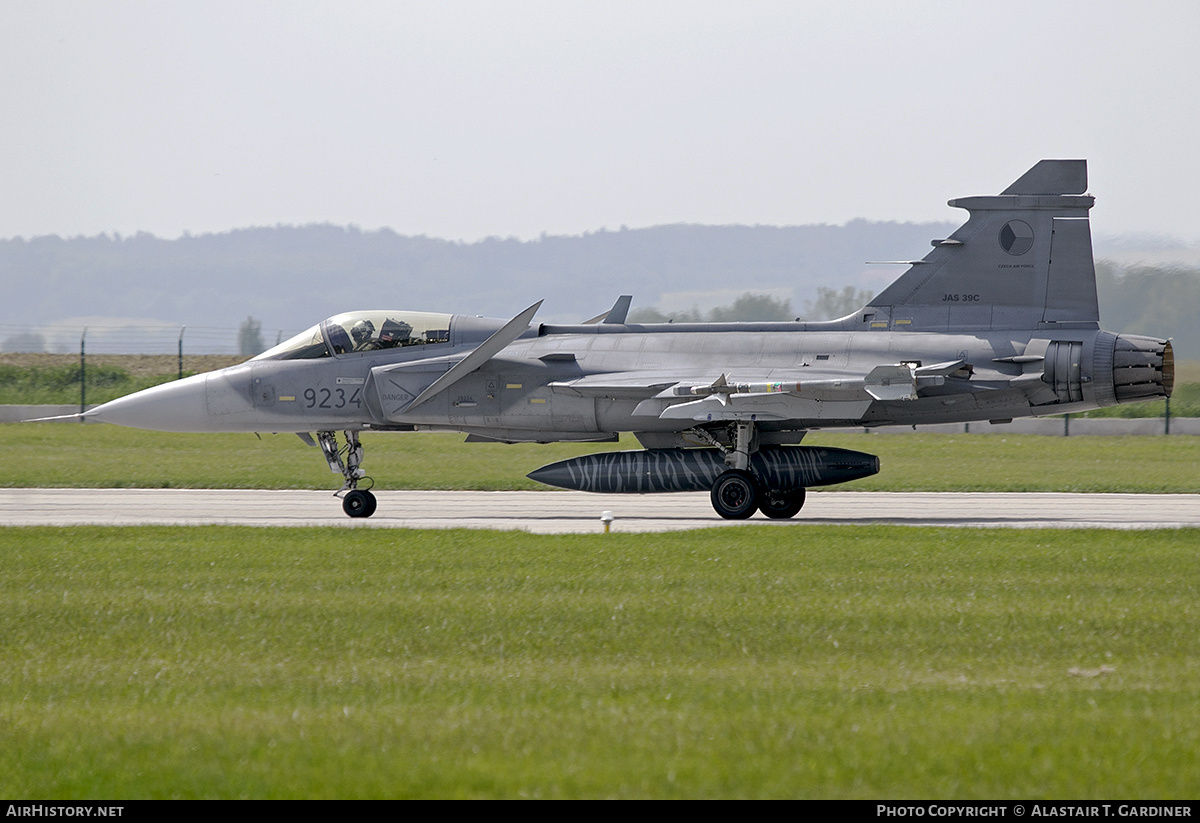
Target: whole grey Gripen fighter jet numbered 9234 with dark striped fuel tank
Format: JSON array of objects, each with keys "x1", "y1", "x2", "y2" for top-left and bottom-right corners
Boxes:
[{"x1": 56, "y1": 160, "x2": 1175, "y2": 519}]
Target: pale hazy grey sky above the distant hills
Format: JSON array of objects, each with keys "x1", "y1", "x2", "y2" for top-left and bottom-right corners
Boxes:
[{"x1": 0, "y1": 0, "x2": 1200, "y2": 241}]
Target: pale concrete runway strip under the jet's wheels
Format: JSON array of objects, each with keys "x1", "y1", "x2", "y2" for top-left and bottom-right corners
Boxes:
[{"x1": 0, "y1": 488, "x2": 1200, "y2": 534}]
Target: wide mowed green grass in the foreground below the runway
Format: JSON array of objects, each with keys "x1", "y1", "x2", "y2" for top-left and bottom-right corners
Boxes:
[{"x1": 0, "y1": 525, "x2": 1200, "y2": 799}]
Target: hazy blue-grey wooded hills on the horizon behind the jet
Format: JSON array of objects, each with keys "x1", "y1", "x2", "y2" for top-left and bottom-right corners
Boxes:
[{"x1": 0, "y1": 220, "x2": 1200, "y2": 359}]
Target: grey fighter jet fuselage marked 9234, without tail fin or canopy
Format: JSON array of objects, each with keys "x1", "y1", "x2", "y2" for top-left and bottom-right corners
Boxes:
[{"x1": 87, "y1": 316, "x2": 1174, "y2": 440}]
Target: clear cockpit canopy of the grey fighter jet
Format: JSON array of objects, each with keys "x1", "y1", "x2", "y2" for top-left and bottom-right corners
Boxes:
[{"x1": 254, "y1": 312, "x2": 451, "y2": 360}]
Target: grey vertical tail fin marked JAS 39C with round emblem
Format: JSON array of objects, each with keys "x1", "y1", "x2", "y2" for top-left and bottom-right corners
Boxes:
[{"x1": 860, "y1": 160, "x2": 1099, "y2": 331}]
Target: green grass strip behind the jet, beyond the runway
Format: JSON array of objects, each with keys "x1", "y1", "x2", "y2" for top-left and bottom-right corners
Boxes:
[{"x1": 7, "y1": 423, "x2": 1200, "y2": 493}]
